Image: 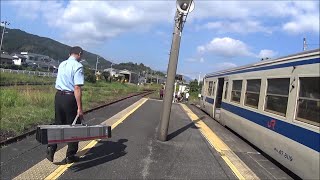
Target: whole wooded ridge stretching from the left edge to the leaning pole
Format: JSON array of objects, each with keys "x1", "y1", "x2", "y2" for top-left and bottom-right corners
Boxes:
[{"x1": 0, "y1": 27, "x2": 168, "y2": 76}]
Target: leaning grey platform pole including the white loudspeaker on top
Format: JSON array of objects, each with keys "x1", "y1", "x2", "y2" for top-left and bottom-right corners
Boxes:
[{"x1": 158, "y1": 0, "x2": 194, "y2": 141}]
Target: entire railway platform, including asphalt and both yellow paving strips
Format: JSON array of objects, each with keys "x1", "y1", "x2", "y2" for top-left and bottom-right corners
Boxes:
[{"x1": 1, "y1": 96, "x2": 295, "y2": 179}]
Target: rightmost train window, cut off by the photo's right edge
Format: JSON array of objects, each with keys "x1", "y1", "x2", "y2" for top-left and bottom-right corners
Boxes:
[{"x1": 297, "y1": 77, "x2": 320, "y2": 126}]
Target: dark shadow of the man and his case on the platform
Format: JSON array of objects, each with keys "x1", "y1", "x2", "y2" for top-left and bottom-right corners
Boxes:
[{"x1": 70, "y1": 139, "x2": 128, "y2": 172}]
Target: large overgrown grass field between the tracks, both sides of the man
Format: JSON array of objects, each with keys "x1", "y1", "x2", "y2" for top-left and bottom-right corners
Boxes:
[{"x1": 0, "y1": 81, "x2": 142, "y2": 135}]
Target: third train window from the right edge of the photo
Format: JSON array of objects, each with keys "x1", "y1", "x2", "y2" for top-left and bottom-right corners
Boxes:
[{"x1": 244, "y1": 79, "x2": 261, "y2": 108}]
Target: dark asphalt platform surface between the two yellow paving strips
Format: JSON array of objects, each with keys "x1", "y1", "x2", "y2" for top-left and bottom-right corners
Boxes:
[{"x1": 60, "y1": 100, "x2": 236, "y2": 179}]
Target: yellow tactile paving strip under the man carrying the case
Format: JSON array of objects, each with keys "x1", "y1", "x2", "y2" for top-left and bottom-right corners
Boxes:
[{"x1": 14, "y1": 98, "x2": 147, "y2": 179}]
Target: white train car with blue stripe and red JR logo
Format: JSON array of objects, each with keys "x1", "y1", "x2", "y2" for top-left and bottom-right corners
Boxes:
[{"x1": 200, "y1": 49, "x2": 320, "y2": 179}]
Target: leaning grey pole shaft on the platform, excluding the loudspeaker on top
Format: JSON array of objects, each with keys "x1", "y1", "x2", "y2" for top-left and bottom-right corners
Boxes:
[{"x1": 158, "y1": 11, "x2": 183, "y2": 141}]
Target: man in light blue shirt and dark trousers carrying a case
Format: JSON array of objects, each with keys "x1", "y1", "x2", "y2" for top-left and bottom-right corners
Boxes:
[{"x1": 47, "y1": 46, "x2": 84, "y2": 163}]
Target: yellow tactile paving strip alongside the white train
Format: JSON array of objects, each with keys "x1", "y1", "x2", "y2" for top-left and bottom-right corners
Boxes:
[{"x1": 180, "y1": 104, "x2": 259, "y2": 179}]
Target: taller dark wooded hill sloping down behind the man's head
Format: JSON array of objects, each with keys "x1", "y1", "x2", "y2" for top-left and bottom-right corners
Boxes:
[{"x1": 1, "y1": 27, "x2": 111, "y2": 68}]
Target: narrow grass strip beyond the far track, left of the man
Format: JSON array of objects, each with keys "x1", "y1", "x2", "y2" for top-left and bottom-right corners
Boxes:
[{"x1": 0, "y1": 72, "x2": 55, "y2": 84}]
